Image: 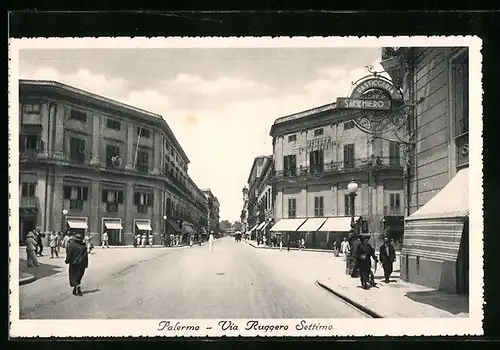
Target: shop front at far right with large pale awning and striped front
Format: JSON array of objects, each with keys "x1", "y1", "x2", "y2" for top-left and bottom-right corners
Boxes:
[{"x1": 401, "y1": 168, "x2": 469, "y2": 294}]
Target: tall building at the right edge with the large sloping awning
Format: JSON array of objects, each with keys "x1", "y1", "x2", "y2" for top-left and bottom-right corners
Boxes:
[{"x1": 381, "y1": 47, "x2": 470, "y2": 293}]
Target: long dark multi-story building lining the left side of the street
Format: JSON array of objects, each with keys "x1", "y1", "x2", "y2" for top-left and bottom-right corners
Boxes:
[{"x1": 19, "y1": 80, "x2": 206, "y2": 245}]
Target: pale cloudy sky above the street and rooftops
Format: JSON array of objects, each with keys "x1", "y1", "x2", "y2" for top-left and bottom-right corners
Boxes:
[{"x1": 19, "y1": 48, "x2": 382, "y2": 221}]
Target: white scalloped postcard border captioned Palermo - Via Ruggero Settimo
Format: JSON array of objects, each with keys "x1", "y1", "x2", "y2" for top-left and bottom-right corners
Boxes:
[{"x1": 9, "y1": 36, "x2": 484, "y2": 337}]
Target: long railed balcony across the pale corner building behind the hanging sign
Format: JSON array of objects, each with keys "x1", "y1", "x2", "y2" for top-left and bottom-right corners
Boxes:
[{"x1": 271, "y1": 157, "x2": 403, "y2": 181}]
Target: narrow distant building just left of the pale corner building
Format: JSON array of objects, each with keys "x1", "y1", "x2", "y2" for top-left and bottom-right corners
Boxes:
[{"x1": 246, "y1": 155, "x2": 274, "y2": 239}]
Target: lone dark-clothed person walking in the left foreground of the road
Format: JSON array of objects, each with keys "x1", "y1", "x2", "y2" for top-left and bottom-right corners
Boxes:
[{"x1": 65, "y1": 232, "x2": 89, "y2": 296}]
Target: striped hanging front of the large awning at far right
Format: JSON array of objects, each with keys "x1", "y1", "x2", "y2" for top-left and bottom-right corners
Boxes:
[{"x1": 401, "y1": 218, "x2": 465, "y2": 261}]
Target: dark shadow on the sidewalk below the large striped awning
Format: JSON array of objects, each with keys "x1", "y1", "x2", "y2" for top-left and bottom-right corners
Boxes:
[{"x1": 405, "y1": 290, "x2": 469, "y2": 315}]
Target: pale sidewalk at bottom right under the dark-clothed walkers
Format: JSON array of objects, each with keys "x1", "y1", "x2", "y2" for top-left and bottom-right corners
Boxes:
[{"x1": 317, "y1": 257, "x2": 469, "y2": 318}]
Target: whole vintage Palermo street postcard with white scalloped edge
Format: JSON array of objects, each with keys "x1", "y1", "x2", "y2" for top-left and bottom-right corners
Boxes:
[{"x1": 9, "y1": 36, "x2": 483, "y2": 338}]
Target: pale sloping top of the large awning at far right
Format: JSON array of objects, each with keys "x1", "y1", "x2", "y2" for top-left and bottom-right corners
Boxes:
[{"x1": 405, "y1": 168, "x2": 469, "y2": 221}]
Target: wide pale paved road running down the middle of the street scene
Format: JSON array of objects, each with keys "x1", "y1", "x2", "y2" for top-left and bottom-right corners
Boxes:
[{"x1": 20, "y1": 238, "x2": 365, "y2": 319}]
